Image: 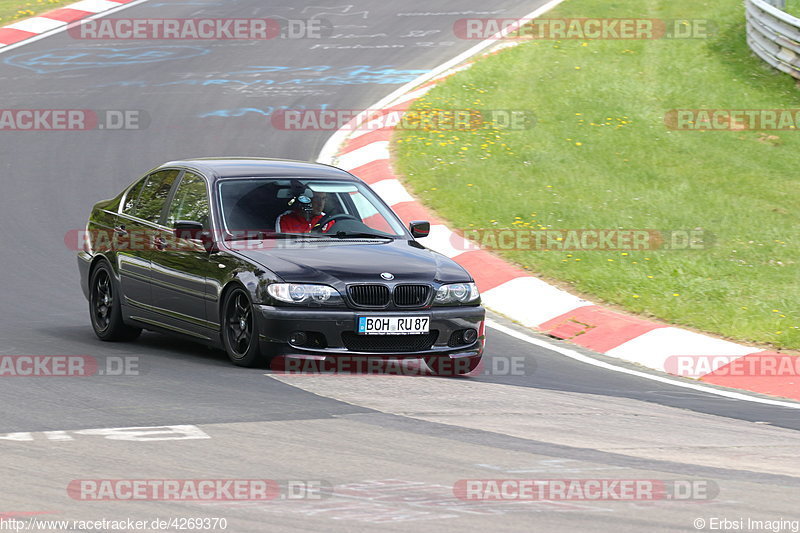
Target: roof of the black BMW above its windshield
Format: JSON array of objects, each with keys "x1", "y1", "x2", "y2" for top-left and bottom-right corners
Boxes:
[{"x1": 159, "y1": 157, "x2": 359, "y2": 181}]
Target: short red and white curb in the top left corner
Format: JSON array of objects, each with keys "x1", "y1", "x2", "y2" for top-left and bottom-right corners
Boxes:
[{"x1": 0, "y1": 0, "x2": 140, "y2": 50}]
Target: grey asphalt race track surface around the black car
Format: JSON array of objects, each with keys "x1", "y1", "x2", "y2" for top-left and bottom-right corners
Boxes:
[{"x1": 0, "y1": 0, "x2": 800, "y2": 533}]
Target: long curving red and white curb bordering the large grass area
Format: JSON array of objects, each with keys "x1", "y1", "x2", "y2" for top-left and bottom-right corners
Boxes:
[{"x1": 318, "y1": 0, "x2": 800, "y2": 400}]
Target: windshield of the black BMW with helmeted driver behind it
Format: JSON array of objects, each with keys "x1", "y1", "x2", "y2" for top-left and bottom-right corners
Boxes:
[{"x1": 219, "y1": 178, "x2": 405, "y2": 240}]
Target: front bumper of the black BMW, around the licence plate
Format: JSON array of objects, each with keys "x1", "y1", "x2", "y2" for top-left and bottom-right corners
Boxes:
[{"x1": 254, "y1": 305, "x2": 486, "y2": 359}]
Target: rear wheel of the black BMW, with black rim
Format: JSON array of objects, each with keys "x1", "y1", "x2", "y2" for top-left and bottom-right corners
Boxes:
[{"x1": 89, "y1": 261, "x2": 142, "y2": 342}]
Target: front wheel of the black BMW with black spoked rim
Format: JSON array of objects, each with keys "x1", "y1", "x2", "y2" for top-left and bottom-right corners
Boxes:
[{"x1": 222, "y1": 288, "x2": 267, "y2": 367}]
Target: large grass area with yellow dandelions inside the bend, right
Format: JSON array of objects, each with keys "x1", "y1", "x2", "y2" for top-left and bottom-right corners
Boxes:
[{"x1": 393, "y1": 0, "x2": 800, "y2": 350}]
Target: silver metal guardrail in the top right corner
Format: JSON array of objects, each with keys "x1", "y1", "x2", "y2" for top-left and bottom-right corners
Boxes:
[{"x1": 744, "y1": 0, "x2": 800, "y2": 79}]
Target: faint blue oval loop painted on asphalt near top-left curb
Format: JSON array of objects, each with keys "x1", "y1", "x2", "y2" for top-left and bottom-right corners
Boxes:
[{"x1": 4, "y1": 46, "x2": 211, "y2": 74}]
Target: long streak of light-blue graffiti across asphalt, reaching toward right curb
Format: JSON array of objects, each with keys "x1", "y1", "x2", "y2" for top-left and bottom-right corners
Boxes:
[{"x1": 99, "y1": 65, "x2": 428, "y2": 88}]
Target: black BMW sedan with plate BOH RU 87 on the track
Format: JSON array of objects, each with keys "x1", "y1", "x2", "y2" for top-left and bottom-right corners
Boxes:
[{"x1": 78, "y1": 158, "x2": 485, "y2": 375}]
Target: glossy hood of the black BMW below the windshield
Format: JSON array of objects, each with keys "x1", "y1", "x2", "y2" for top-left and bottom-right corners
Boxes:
[{"x1": 230, "y1": 240, "x2": 472, "y2": 285}]
